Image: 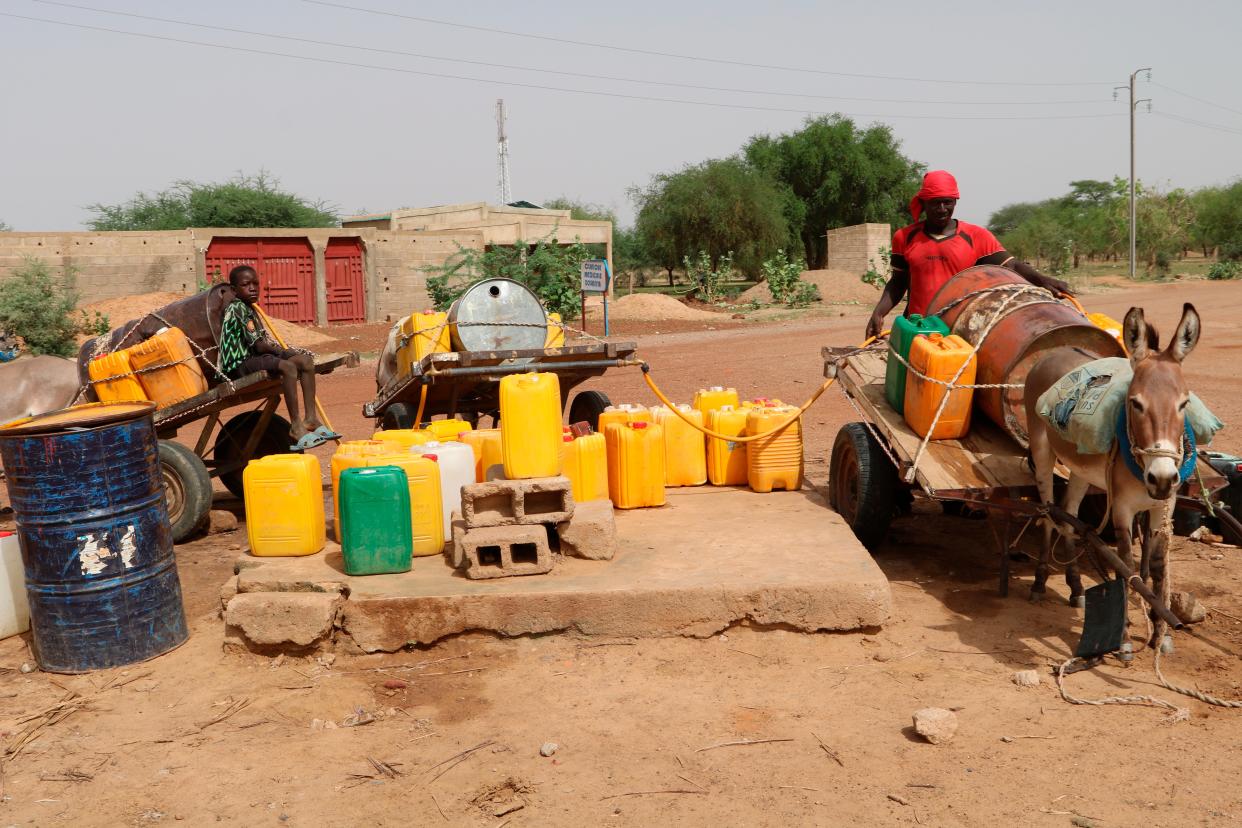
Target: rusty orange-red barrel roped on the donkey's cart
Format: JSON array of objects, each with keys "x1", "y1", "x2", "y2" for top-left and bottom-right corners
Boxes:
[{"x1": 927, "y1": 264, "x2": 1125, "y2": 446}]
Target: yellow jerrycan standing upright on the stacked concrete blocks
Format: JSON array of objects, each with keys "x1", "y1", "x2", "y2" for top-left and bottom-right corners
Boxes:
[{"x1": 501, "y1": 372, "x2": 561, "y2": 480}]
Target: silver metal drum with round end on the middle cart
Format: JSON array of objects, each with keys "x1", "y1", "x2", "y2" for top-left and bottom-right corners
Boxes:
[{"x1": 448, "y1": 279, "x2": 548, "y2": 351}]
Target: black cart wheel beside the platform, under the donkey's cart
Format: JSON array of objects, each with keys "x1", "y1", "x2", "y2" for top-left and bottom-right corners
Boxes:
[{"x1": 828, "y1": 422, "x2": 898, "y2": 549}]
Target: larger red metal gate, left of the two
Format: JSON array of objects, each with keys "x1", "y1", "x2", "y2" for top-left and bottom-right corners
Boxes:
[{"x1": 206, "y1": 238, "x2": 315, "y2": 325}]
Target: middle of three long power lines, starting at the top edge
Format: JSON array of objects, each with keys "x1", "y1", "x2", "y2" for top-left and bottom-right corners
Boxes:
[{"x1": 34, "y1": 0, "x2": 1100, "y2": 107}]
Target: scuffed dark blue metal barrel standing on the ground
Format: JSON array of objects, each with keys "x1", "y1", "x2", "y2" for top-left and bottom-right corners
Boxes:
[{"x1": 0, "y1": 402, "x2": 189, "y2": 673}]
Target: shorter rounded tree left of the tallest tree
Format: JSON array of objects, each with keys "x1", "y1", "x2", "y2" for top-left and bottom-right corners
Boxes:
[{"x1": 630, "y1": 158, "x2": 790, "y2": 284}]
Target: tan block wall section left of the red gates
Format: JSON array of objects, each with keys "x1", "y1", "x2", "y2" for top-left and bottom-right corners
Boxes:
[{"x1": 0, "y1": 230, "x2": 197, "y2": 304}]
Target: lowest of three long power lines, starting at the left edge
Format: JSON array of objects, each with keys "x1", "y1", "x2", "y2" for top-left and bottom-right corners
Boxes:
[{"x1": 0, "y1": 12, "x2": 1119, "y2": 120}]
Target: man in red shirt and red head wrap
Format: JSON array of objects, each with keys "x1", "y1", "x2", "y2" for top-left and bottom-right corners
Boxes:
[{"x1": 867, "y1": 170, "x2": 1071, "y2": 336}]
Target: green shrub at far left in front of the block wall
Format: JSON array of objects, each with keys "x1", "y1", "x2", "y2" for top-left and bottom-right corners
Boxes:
[{"x1": 0, "y1": 257, "x2": 111, "y2": 356}]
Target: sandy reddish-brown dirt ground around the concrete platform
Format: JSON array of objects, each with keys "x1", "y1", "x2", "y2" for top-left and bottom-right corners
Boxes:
[{"x1": 0, "y1": 276, "x2": 1242, "y2": 828}]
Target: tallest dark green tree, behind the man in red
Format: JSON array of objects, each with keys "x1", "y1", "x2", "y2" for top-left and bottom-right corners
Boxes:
[{"x1": 743, "y1": 115, "x2": 925, "y2": 268}]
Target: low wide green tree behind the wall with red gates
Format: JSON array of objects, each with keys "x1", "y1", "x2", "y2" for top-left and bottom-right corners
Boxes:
[{"x1": 87, "y1": 170, "x2": 339, "y2": 230}]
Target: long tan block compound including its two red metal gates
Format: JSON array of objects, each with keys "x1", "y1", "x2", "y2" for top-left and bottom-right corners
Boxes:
[{"x1": 0, "y1": 202, "x2": 612, "y2": 325}]
